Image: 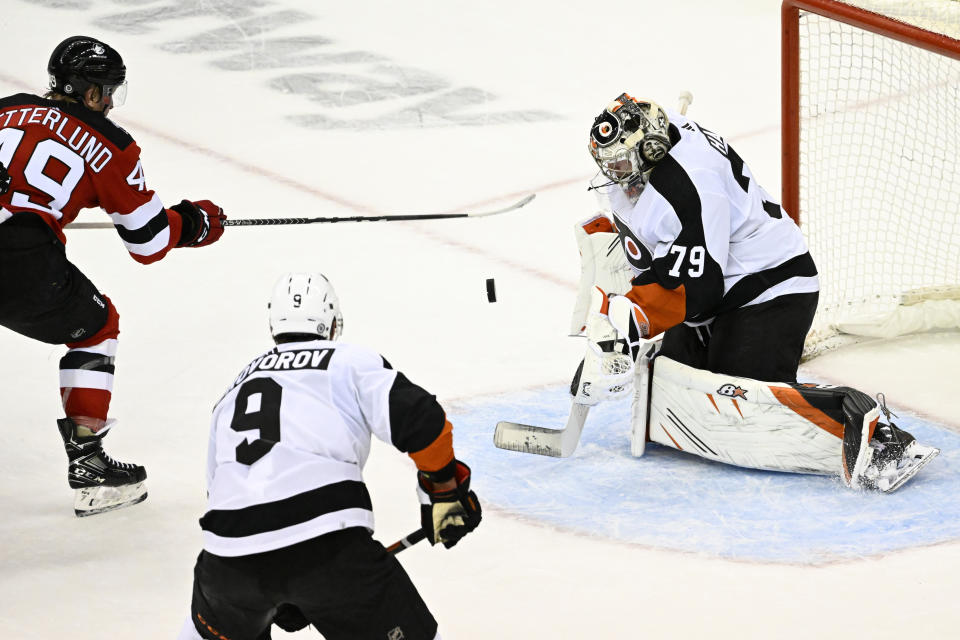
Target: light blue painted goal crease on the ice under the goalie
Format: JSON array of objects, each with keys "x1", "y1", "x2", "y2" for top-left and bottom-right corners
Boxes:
[{"x1": 450, "y1": 388, "x2": 960, "y2": 564}]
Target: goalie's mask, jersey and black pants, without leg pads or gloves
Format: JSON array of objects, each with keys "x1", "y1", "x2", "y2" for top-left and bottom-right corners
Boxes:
[{"x1": 589, "y1": 94, "x2": 819, "y2": 382}]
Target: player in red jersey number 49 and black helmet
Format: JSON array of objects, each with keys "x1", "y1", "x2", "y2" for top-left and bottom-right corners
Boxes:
[{"x1": 0, "y1": 36, "x2": 226, "y2": 516}]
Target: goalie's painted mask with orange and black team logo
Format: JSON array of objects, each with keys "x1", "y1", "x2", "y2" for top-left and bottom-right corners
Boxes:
[{"x1": 589, "y1": 93, "x2": 670, "y2": 190}]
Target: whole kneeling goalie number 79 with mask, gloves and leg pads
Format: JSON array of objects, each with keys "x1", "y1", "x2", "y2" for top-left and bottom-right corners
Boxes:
[{"x1": 571, "y1": 93, "x2": 938, "y2": 491}]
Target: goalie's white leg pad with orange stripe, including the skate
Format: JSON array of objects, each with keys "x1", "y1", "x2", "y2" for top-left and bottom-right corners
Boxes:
[{"x1": 631, "y1": 357, "x2": 940, "y2": 492}]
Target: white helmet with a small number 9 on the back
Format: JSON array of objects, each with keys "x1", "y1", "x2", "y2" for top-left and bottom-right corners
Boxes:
[{"x1": 268, "y1": 273, "x2": 343, "y2": 340}]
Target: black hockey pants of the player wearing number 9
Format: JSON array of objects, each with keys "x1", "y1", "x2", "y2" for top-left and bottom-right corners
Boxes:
[{"x1": 191, "y1": 527, "x2": 437, "y2": 640}]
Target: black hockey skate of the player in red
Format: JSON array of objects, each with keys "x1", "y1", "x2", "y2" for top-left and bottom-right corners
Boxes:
[{"x1": 57, "y1": 418, "x2": 147, "y2": 517}]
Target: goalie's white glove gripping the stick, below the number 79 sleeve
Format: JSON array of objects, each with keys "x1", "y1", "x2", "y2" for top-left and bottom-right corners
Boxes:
[{"x1": 570, "y1": 287, "x2": 650, "y2": 406}]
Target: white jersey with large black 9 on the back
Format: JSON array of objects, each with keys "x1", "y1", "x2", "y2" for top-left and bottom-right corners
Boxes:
[{"x1": 200, "y1": 340, "x2": 453, "y2": 556}]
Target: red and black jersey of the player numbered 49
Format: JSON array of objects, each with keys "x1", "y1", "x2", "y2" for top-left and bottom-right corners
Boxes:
[{"x1": 0, "y1": 93, "x2": 181, "y2": 264}]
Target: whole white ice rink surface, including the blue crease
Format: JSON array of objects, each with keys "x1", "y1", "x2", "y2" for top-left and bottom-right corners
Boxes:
[{"x1": 0, "y1": 0, "x2": 960, "y2": 640}]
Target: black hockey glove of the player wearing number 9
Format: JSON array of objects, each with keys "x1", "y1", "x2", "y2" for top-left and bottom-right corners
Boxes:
[{"x1": 417, "y1": 460, "x2": 481, "y2": 549}]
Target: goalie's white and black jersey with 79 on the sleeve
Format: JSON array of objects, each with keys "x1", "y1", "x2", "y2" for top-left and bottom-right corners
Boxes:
[{"x1": 596, "y1": 112, "x2": 819, "y2": 336}]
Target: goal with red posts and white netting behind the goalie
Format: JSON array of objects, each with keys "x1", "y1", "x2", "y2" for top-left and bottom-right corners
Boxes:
[{"x1": 781, "y1": 0, "x2": 960, "y2": 357}]
